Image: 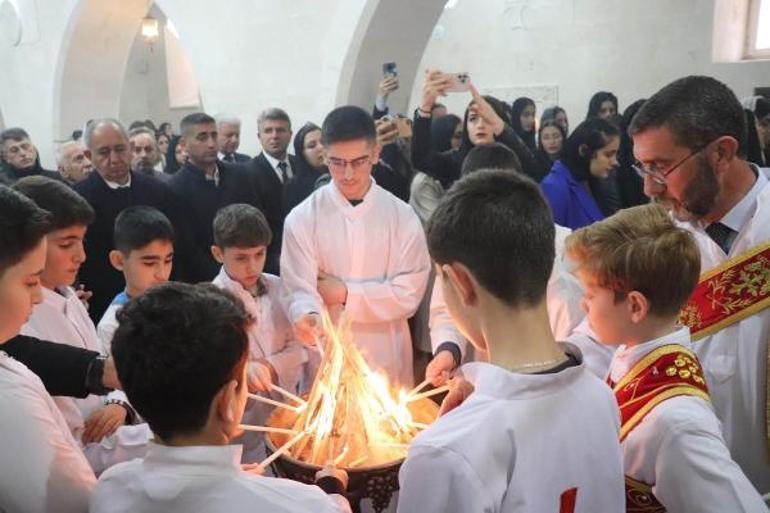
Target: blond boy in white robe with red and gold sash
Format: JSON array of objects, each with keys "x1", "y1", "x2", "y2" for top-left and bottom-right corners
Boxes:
[{"x1": 567, "y1": 204, "x2": 767, "y2": 513}]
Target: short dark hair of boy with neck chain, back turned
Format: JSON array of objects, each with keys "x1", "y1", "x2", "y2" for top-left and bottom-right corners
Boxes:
[{"x1": 426, "y1": 169, "x2": 555, "y2": 308}]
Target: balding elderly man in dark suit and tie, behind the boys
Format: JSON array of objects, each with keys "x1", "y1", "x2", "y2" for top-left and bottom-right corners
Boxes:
[{"x1": 74, "y1": 118, "x2": 189, "y2": 322}]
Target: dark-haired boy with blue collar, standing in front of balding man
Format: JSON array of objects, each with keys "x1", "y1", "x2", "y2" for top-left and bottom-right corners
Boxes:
[{"x1": 96, "y1": 205, "x2": 174, "y2": 354}]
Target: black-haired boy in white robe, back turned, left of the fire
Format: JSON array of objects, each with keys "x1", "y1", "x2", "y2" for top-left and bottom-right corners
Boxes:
[{"x1": 90, "y1": 282, "x2": 349, "y2": 513}]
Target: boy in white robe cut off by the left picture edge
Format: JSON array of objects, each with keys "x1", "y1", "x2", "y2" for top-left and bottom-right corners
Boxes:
[{"x1": 0, "y1": 186, "x2": 96, "y2": 513}]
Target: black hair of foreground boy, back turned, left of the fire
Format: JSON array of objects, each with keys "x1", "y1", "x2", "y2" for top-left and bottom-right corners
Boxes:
[{"x1": 112, "y1": 282, "x2": 250, "y2": 441}]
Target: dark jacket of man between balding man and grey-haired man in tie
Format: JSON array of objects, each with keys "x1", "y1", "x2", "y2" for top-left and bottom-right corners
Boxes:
[{"x1": 168, "y1": 161, "x2": 260, "y2": 282}]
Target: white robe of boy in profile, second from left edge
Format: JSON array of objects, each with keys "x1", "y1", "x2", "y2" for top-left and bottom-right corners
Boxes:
[{"x1": 21, "y1": 287, "x2": 153, "y2": 474}]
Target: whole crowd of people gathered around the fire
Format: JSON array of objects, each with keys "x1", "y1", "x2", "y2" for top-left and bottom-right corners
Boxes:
[{"x1": 0, "y1": 70, "x2": 770, "y2": 513}]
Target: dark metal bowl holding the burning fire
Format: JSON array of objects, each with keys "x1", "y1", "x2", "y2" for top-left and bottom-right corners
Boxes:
[{"x1": 265, "y1": 398, "x2": 438, "y2": 513}]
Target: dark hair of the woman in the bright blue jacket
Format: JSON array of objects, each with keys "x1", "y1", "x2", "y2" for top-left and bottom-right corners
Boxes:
[{"x1": 560, "y1": 118, "x2": 620, "y2": 182}]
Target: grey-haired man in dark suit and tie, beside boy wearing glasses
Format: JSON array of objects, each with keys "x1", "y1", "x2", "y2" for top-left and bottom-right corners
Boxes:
[{"x1": 246, "y1": 108, "x2": 297, "y2": 274}]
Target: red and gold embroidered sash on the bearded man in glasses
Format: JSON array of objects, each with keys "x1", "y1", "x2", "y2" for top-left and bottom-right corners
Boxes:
[{"x1": 679, "y1": 242, "x2": 770, "y2": 341}]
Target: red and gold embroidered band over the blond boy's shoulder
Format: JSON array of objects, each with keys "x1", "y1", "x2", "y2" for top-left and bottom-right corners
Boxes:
[{"x1": 608, "y1": 344, "x2": 710, "y2": 442}]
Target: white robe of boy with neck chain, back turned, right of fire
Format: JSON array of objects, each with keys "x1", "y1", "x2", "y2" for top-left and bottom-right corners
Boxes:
[{"x1": 398, "y1": 345, "x2": 625, "y2": 513}]
